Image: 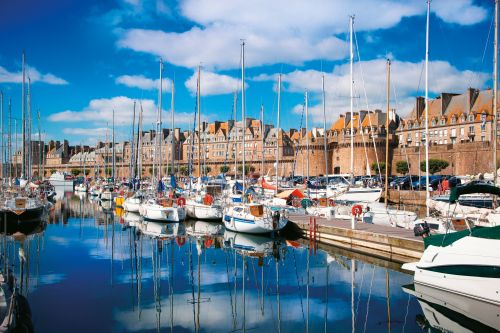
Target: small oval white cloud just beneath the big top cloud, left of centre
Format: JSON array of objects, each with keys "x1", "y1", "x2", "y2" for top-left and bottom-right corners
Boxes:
[{"x1": 184, "y1": 71, "x2": 242, "y2": 96}]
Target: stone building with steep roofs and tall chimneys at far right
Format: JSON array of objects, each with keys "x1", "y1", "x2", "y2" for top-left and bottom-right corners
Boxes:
[{"x1": 392, "y1": 88, "x2": 500, "y2": 175}]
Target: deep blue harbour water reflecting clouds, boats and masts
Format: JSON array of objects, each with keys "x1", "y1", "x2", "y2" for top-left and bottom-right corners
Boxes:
[{"x1": 3, "y1": 195, "x2": 494, "y2": 332}]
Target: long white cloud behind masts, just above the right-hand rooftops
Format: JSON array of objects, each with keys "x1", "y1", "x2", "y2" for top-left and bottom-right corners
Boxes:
[{"x1": 253, "y1": 59, "x2": 490, "y2": 124}]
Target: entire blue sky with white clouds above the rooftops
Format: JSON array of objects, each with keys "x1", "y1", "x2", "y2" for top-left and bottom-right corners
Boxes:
[{"x1": 0, "y1": 0, "x2": 494, "y2": 144}]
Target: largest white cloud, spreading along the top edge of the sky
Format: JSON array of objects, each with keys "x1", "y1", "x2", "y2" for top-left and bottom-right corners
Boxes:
[{"x1": 118, "y1": 0, "x2": 487, "y2": 69}]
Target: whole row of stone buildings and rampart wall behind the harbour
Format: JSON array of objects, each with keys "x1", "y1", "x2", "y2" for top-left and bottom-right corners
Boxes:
[{"x1": 6, "y1": 88, "x2": 500, "y2": 177}]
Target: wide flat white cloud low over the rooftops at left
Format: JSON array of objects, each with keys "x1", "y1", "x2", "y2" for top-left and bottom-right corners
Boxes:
[{"x1": 49, "y1": 96, "x2": 206, "y2": 128}]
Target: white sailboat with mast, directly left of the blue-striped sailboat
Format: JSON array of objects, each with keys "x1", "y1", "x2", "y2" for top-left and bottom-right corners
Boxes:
[{"x1": 184, "y1": 66, "x2": 222, "y2": 220}]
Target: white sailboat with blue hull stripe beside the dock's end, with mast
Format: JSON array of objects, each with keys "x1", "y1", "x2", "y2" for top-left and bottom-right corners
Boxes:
[{"x1": 223, "y1": 41, "x2": 288, "y2": 234}]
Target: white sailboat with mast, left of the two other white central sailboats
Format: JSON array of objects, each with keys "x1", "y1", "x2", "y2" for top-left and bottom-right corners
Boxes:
[{"x1": 139, "y1": 59, "x2": 186, "y2": 222}]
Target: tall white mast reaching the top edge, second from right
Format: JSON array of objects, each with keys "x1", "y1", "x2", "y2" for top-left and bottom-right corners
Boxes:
[{"x1": 425, "y1": 0, "x2": 430, "y2": 217}]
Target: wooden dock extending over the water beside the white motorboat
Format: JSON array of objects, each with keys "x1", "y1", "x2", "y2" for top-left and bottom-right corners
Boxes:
[{"x1": 289, "y1": 215, "x2": 424, "y2": 263}]
